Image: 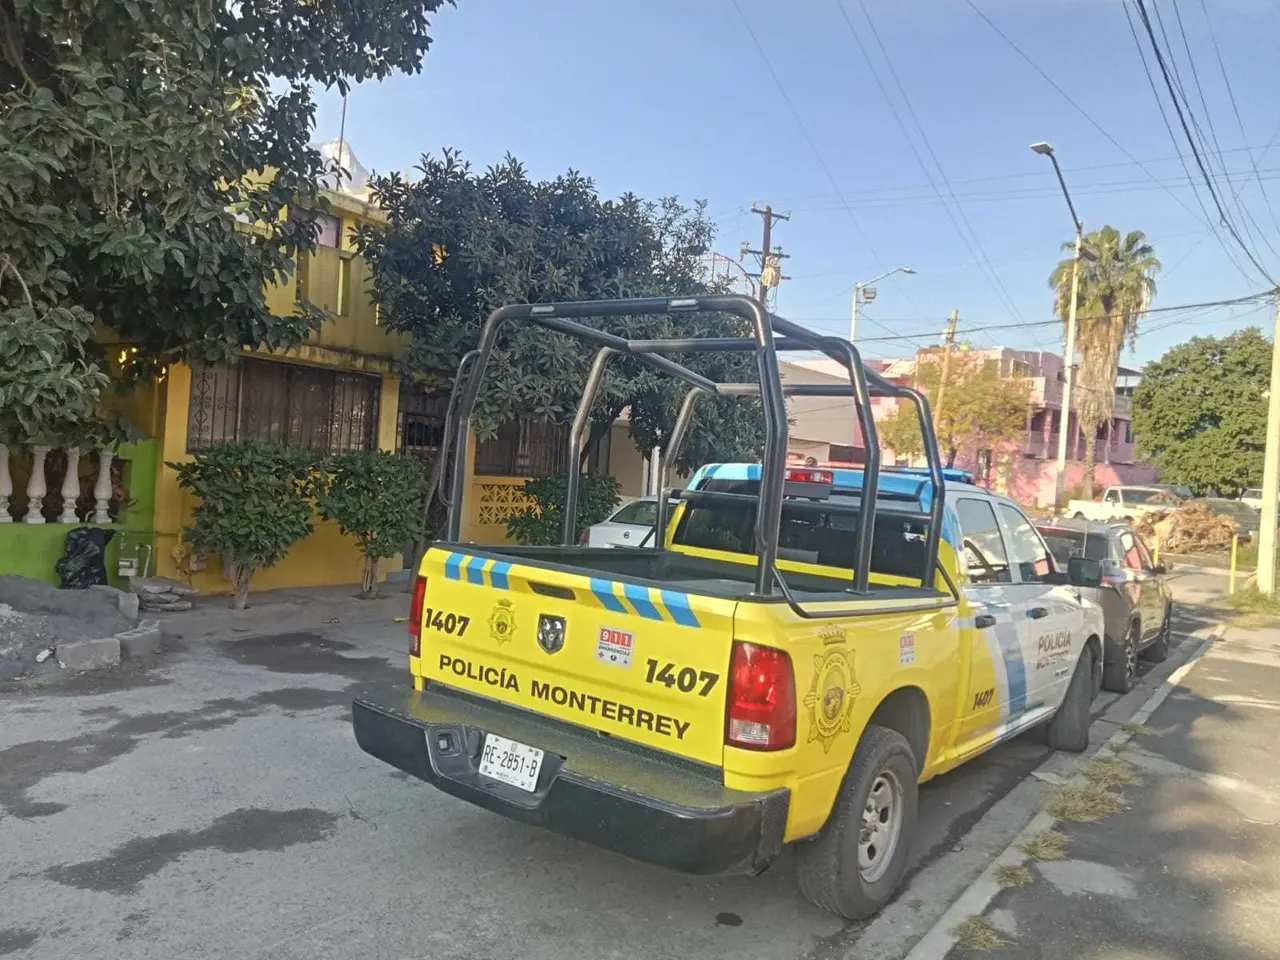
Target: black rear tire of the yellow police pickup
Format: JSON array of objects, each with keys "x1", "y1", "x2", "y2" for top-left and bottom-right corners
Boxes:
[{"x1": 796, "y1": 726, "x2": 919, "y2": 920}]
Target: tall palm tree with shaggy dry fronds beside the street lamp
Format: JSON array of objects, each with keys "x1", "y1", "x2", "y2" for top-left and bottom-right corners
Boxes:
[{"x1": 1048, "y1": 225, "x2": 1160, "y2": 497}]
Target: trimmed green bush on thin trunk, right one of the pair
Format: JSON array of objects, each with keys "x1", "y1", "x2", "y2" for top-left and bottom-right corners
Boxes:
[{"x1": 316, "y1": 451, "x2": 426, "y2": 596}]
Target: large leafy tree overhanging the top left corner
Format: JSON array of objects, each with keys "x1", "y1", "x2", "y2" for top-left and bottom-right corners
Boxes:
[{"x1": 0, "y1": 0, "x2": 455, "y2": 439}]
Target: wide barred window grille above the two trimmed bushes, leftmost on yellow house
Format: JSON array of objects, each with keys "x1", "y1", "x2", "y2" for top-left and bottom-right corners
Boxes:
[{"x1": 187, "y1": 357, "x2": 379, "y2": 454}]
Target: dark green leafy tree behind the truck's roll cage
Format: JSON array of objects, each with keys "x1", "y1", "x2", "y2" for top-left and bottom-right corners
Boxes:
[{"x1": 357, "y1": 150, "x2": 762, "y2": 465}]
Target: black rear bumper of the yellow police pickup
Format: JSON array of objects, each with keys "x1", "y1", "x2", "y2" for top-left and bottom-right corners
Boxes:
[{"x1": 352, "y1": 686, "x2": 790, "y2": 874}]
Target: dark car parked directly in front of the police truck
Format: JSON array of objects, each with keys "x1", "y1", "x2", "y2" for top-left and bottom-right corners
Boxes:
[{"x1": 1039, "y1": 518, "x2": 1172, "y2": 694}]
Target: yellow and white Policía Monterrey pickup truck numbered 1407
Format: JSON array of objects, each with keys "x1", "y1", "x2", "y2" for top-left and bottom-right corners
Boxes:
[{"x1": 352, "y1": 296, "x2": 1102, "y2": 919}]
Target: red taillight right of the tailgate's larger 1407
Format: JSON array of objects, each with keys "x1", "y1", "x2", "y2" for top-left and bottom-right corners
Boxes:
[{"x1": 724, "y1": 643, "x2": 796, "y2": 750}]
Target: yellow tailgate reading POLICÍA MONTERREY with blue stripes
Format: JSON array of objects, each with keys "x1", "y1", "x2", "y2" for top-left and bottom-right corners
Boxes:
[{"x1": 410, "y1": 548, "x2": 736, "y2": 765}]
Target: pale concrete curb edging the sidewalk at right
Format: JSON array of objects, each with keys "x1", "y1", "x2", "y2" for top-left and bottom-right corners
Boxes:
[{"x1": 904, "y1": 622, "x2": 1225, "y2": 960}]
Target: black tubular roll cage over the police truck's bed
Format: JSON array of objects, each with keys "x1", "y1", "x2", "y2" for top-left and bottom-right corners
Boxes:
[{"x1": 442, "y1": 294, "x2": 946, "y2": 617}]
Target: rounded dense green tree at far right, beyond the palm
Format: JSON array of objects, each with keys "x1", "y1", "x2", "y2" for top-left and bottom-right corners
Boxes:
[{"x1": 1133, "y1": 326, "x2": 1271, "y2": 495}]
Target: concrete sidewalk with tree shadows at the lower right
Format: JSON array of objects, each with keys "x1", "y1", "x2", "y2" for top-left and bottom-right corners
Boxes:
[{"x1": 942, "y1": 619, "x2": 1280, "y2": 960}]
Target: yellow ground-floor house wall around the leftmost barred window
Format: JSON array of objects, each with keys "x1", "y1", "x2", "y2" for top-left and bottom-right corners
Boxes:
[{"x1": 155, "y1": 364, "x2": 403, "y2": 594}]
